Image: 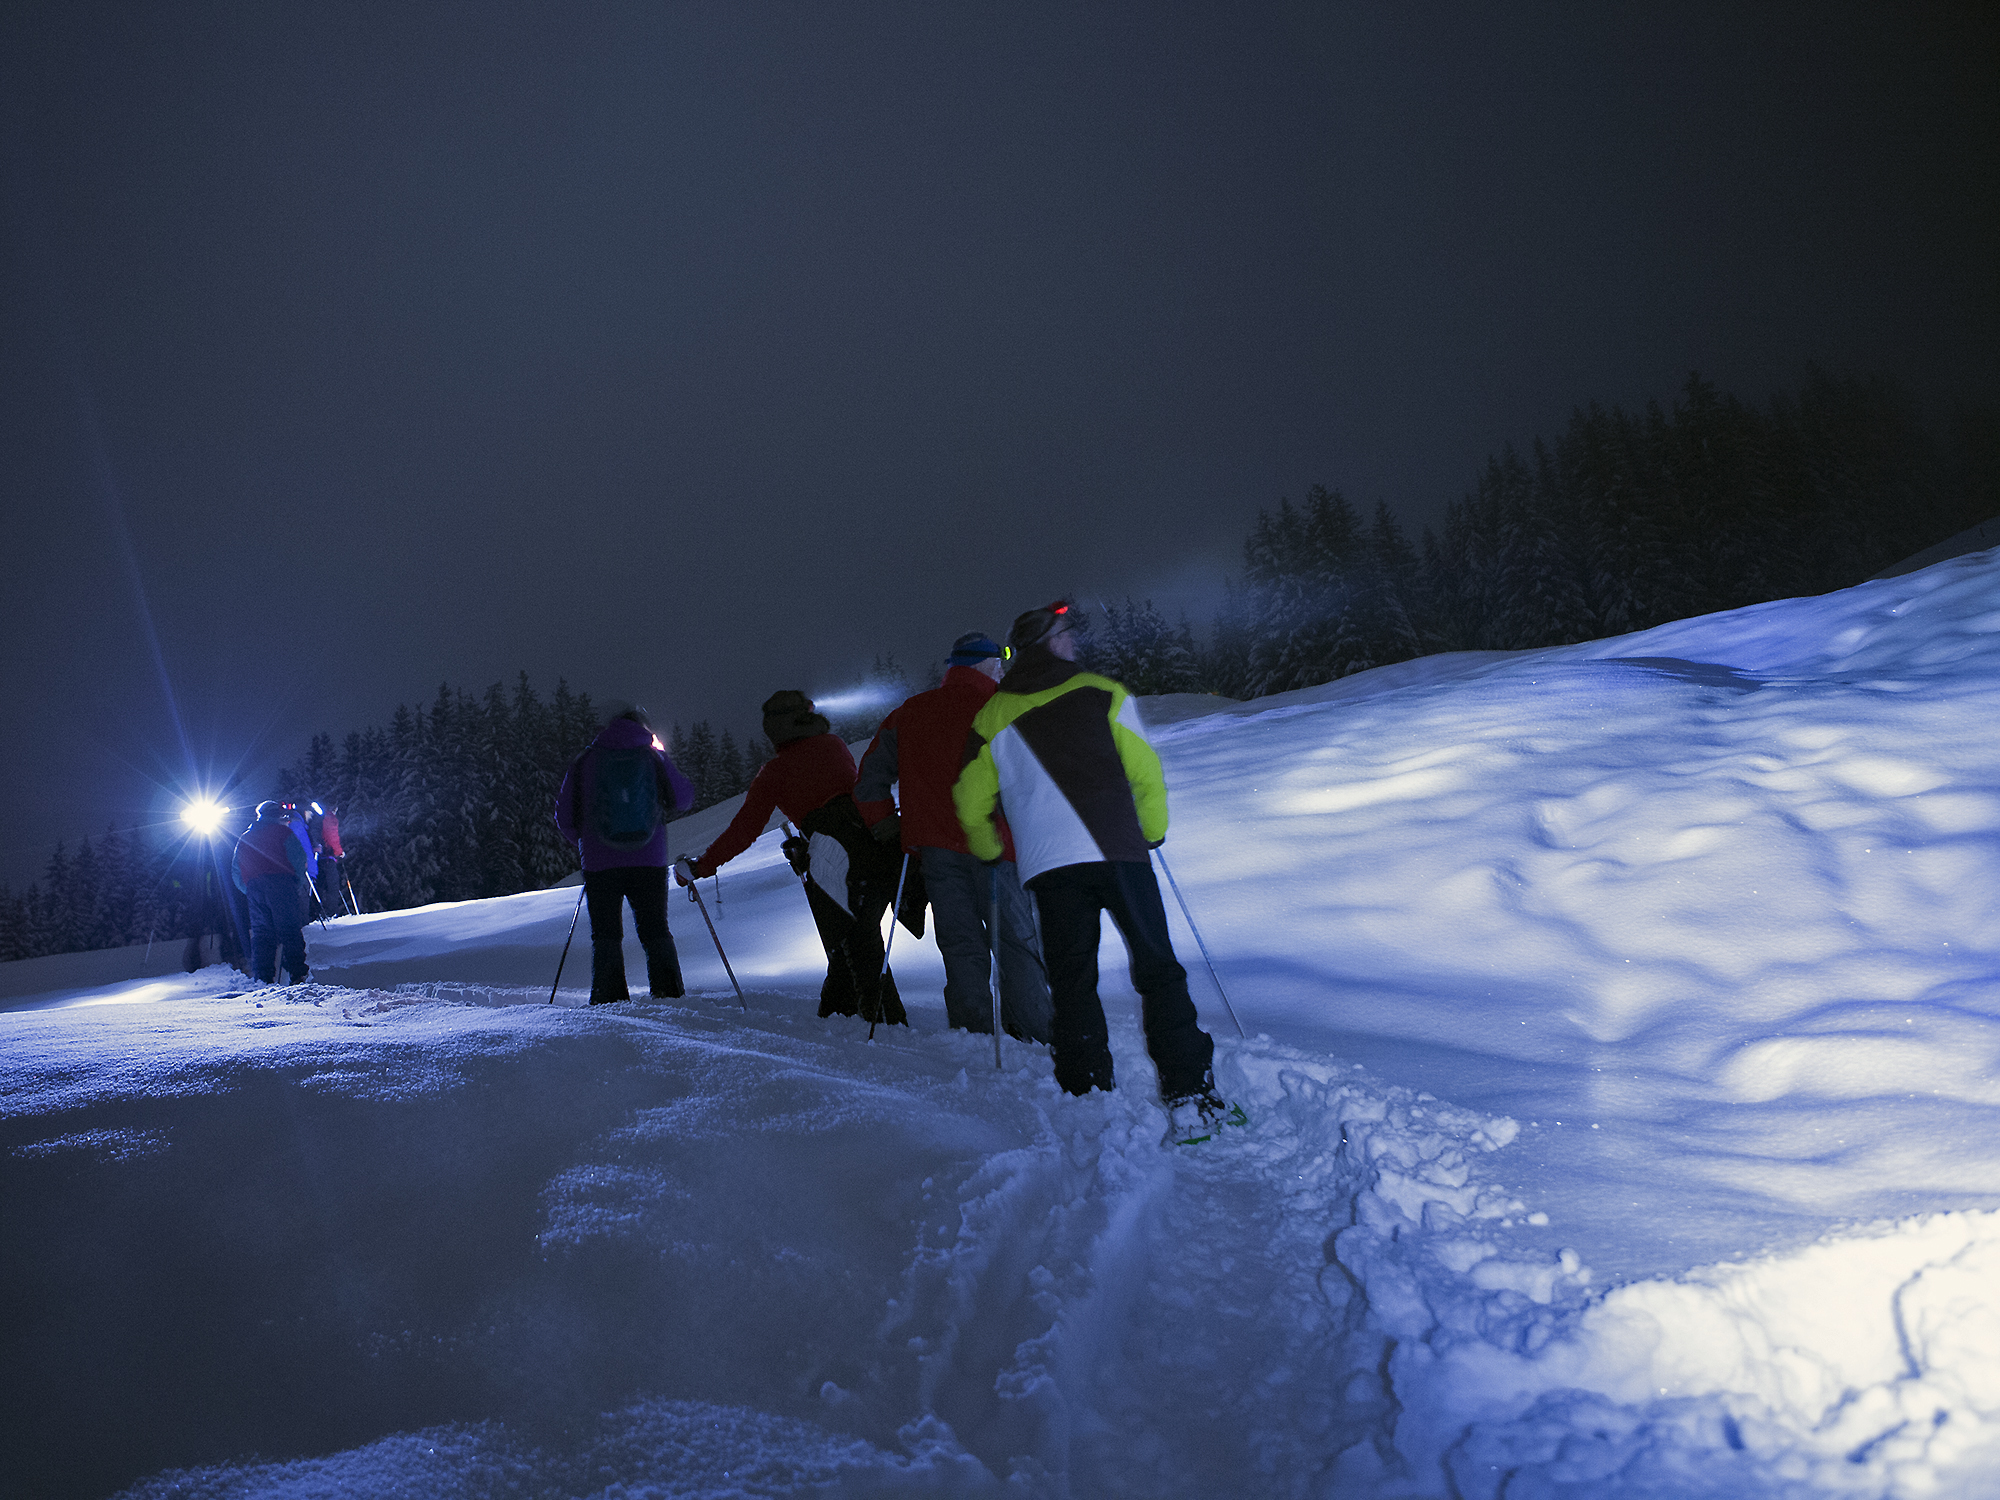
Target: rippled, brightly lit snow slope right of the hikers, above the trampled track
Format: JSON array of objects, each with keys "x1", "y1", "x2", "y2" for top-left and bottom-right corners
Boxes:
[{"x1": 1154, "y1": 554, "x2": 2000, "y2": 1278}]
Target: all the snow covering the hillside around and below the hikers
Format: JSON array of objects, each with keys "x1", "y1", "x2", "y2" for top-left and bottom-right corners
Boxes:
[{"x1": 11, "y1": 552, "x2": 2000, "y2": 1500}]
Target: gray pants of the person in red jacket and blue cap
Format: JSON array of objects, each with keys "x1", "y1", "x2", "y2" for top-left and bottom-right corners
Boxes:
[{"x1": 924, "y1": 848, "x2": 1056, "y2": 1042}]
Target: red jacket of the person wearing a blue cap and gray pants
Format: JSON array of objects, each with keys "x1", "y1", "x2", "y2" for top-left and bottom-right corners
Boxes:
[{"x1": 854, "y1": 666, "x2": 1014, "y2": 860}]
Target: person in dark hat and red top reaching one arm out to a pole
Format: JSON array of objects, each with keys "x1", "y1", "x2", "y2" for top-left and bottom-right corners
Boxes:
[{"x1": 680, "y1": 690, "x2": 908, "y2": 1026}]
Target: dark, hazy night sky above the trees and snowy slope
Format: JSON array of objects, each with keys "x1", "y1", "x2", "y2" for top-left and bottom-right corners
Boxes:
[{"x1": 0, "y1": 0, "x2": 2000, "y2": 886}]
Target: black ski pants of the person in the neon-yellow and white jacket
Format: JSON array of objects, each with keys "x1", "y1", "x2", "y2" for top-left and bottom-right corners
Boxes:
[{"x1": 1028, "y1": 860, "x2": 1216, "y2": 1100}]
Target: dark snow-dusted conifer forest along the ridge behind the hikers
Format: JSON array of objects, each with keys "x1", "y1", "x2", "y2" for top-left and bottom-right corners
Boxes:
[{"x1": 0, "y1": 374, "x2": 2000, "y2": 960}]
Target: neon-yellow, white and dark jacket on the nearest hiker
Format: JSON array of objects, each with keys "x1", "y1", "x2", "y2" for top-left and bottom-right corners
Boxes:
[{"x1": 952, "y1": 648, "x2": 1166, "y2": 880}]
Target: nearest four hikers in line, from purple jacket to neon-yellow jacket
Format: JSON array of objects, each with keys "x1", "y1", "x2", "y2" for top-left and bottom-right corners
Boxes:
[{"x1": 554, "y1": 600, "x2": 1228, "y2": 1138}]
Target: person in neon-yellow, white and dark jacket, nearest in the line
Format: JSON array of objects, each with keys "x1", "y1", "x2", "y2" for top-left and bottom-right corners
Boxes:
[{"x1": 952, "y1": 600, "x2": 1228, "y2": 1124}]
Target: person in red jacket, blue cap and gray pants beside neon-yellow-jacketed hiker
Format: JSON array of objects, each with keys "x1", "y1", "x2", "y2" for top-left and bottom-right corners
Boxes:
[{"x1": 854, "y1": 630, "x2": 1054, "y2": 1042}]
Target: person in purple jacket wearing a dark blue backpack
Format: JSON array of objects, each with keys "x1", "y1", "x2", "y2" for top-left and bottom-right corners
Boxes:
[{"x1": 556, "y1": 704, "x2": 694, "y2": 1006}]
